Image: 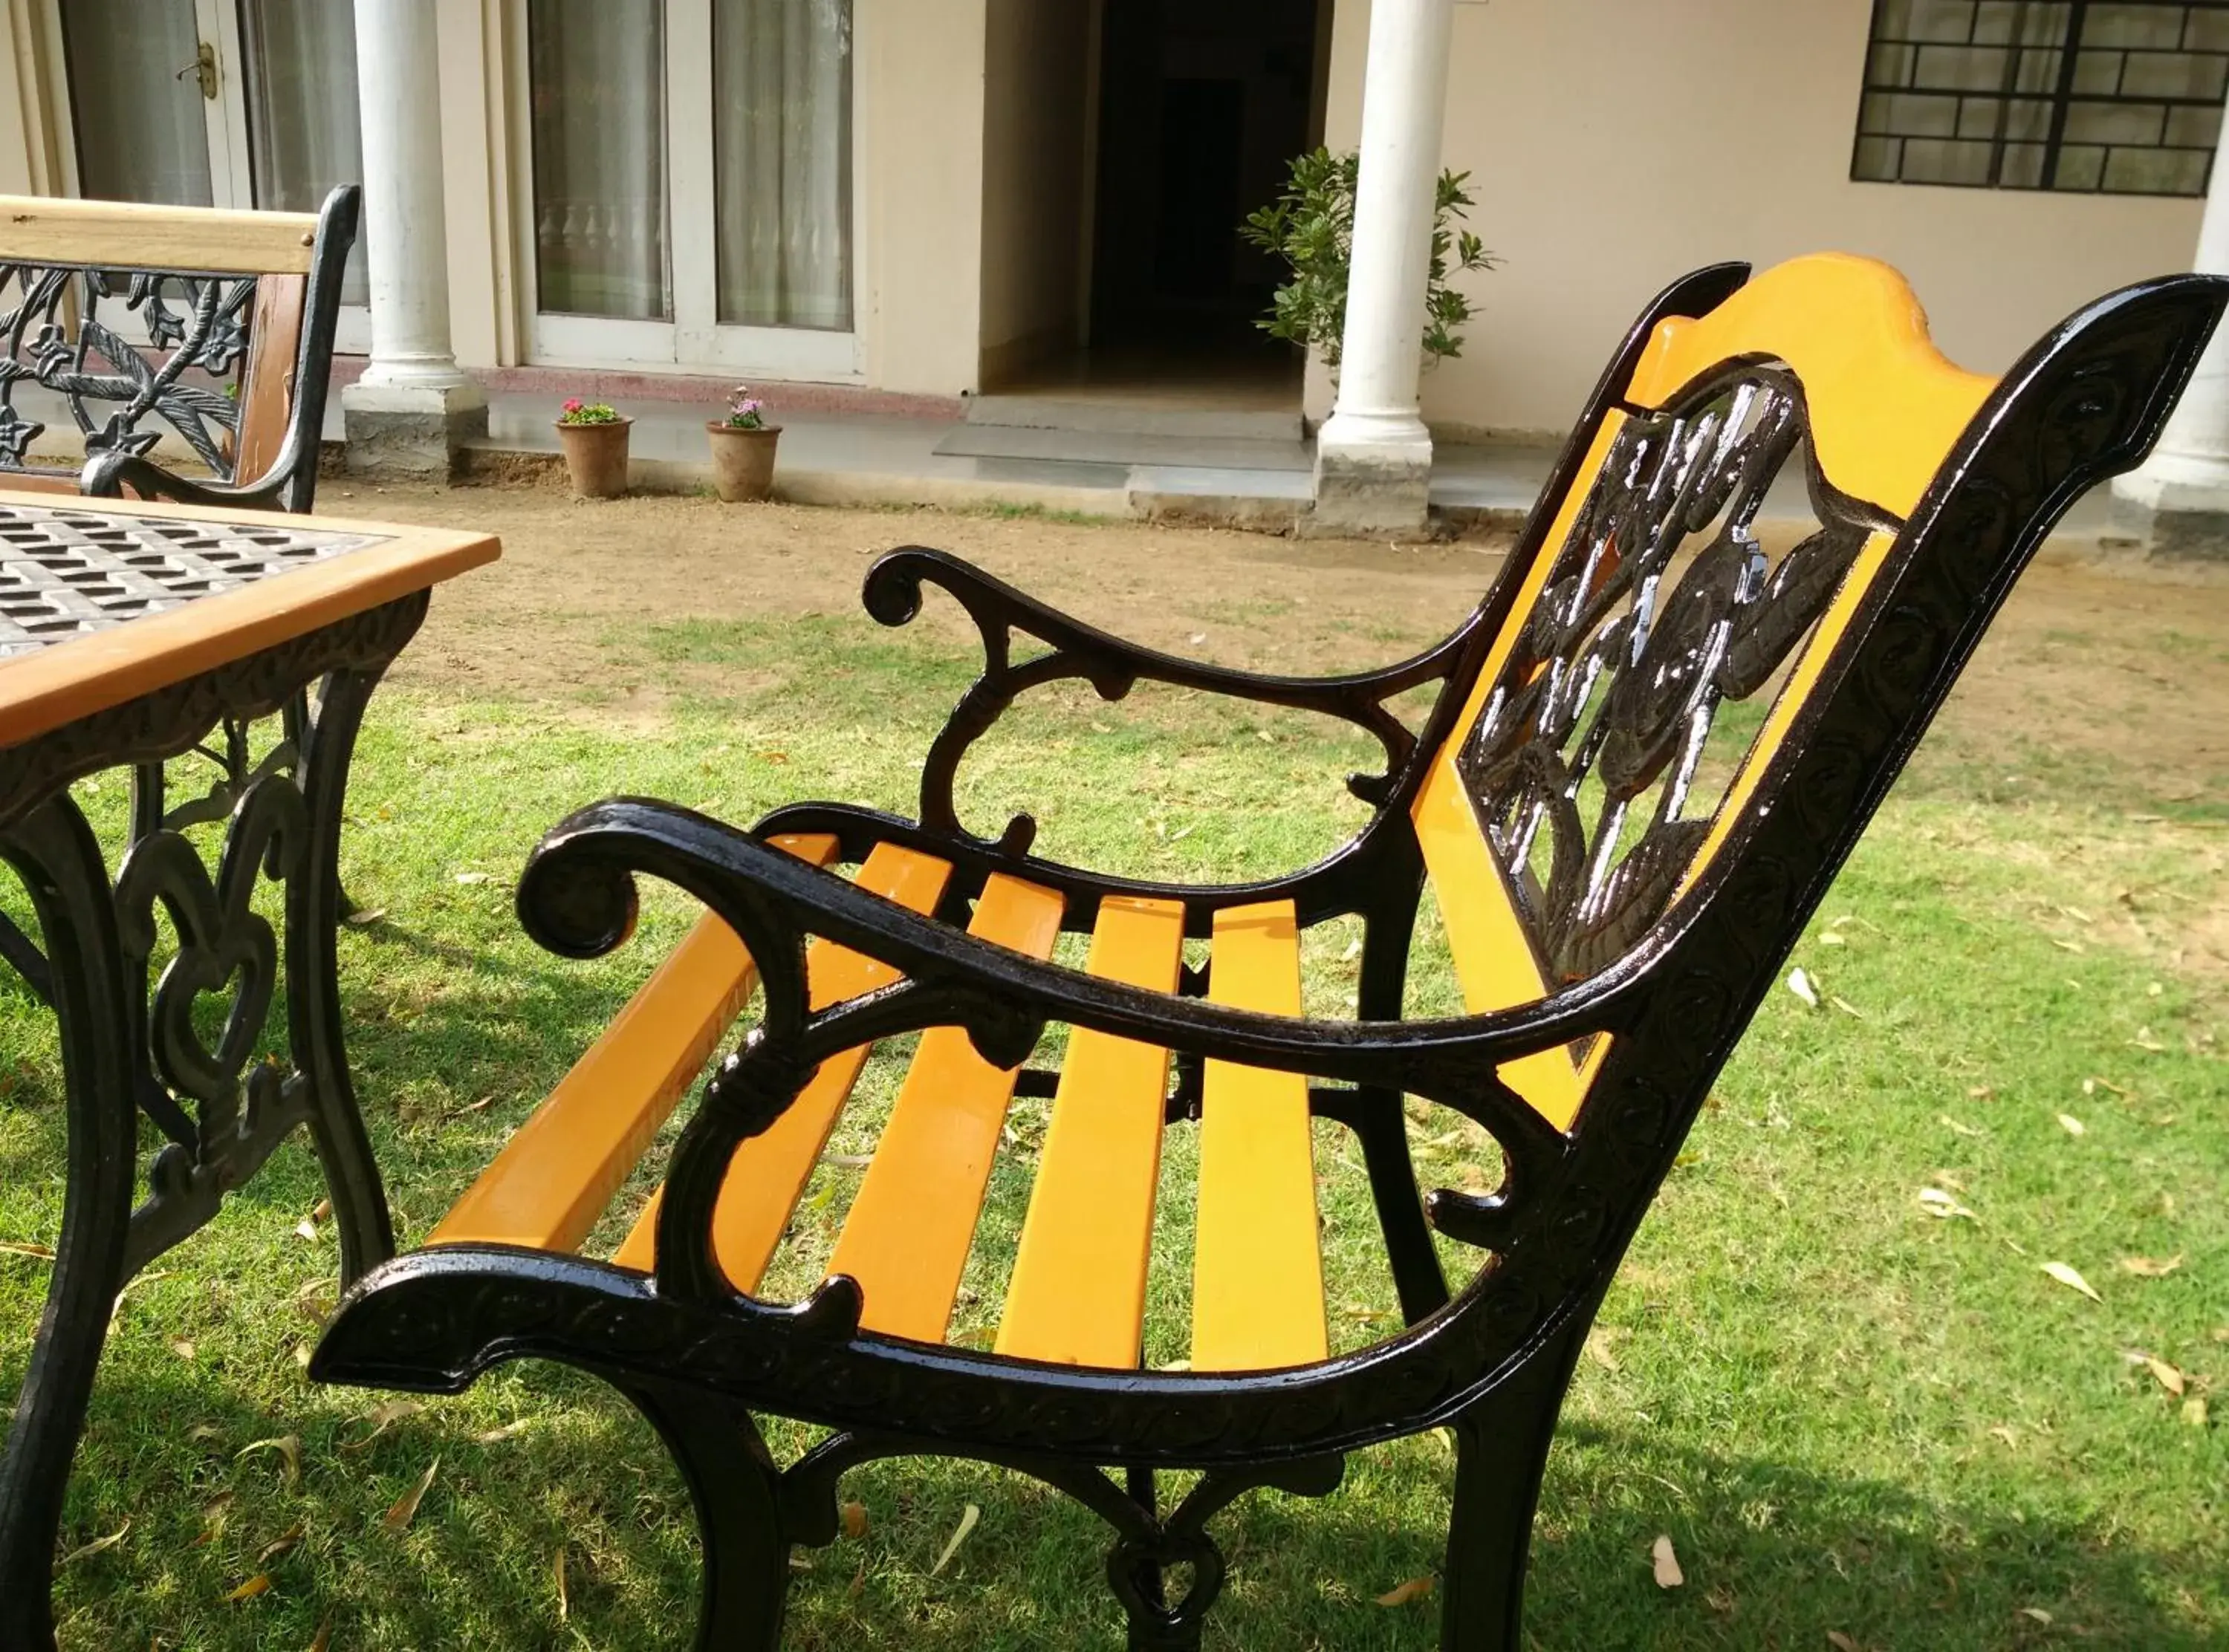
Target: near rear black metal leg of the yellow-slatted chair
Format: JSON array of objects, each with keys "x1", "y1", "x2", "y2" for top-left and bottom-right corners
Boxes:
[{"x1": 1440, "y1": 1313, "x2": 1594, "y2": 1652}]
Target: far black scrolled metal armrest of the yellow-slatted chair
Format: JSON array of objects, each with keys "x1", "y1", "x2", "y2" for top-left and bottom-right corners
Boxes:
[{"x1": 860, "y1": 546, "x2": 1469, "y2": 854}]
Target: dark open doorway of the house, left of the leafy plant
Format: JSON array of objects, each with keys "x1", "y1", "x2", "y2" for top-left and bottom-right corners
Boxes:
[{"x1": 1090, "y1": 0, "x2": 1333, "y2": 390}]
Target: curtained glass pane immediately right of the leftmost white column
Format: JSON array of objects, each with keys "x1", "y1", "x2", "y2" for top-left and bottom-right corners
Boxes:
[{"x1": 526, "y1": 0, "x2": 673, "y2": 321}]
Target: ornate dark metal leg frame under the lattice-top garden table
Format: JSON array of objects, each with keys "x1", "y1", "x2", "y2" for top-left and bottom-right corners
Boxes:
[{"x1": 0, "y1": 615, "x2": 424, "y2": 1652}]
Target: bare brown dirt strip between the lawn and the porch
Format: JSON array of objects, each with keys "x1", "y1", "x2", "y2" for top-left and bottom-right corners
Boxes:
[{"x1": 334, "y1": 481, "x2": 2229, "y2": 802}]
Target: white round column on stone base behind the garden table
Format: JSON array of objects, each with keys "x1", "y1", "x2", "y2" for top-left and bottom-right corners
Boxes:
[{"x1": 341, "y1": 0, "x2": 488, "y2": 475}]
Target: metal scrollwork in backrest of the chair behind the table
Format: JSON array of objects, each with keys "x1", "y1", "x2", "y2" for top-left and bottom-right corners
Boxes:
[{"x1": 0, "y1": 263, "x2": 256, "y2": 481}]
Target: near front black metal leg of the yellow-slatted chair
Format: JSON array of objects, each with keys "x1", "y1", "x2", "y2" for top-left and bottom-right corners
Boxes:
[{"x1": 620, "y1": 1382, "x2": 789, "y2": 1652}]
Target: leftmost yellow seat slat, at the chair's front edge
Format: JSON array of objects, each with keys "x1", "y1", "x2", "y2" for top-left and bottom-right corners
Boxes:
[{"x1": 426, "y1": 834, "x2": 836, "y2": 1251}]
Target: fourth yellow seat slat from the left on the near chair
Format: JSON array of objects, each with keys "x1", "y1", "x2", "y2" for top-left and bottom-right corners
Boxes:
[{"x1": 996, "y1": 897, "x2": 1184, "y2": 1369}]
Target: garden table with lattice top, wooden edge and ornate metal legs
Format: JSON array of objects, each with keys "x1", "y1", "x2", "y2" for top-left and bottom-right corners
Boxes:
[{"x1": 0, "y1": 490, "x2": 497, "y2": 1652}]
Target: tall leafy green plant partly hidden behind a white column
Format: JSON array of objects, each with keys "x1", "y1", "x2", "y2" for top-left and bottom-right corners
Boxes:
[{"x1": 1239, "y1": 147, "x2": 1500, "y2": 368}]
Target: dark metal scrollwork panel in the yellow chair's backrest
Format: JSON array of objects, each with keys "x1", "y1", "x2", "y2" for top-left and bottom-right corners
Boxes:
[{"x1": 1458, "y1": 365, "x2": 1901, "y2": 981}]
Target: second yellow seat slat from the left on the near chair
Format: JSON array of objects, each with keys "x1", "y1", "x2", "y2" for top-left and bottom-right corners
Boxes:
[{"x1": 613, "y1": 843, "x2": 952, "y2": 1291}]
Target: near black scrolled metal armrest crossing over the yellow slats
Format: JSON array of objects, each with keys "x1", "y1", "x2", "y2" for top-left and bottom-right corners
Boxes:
[{"x1": 517, "y1": 798, "x2": 1605, "y2": 1242}]
